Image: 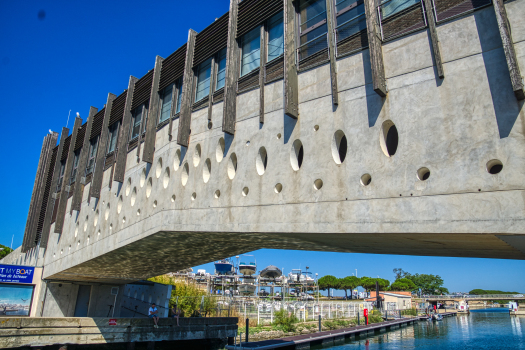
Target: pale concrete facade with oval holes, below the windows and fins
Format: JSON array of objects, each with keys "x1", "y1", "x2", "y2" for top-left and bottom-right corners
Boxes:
[{"x1": 3, "y1": 0, "x2": 525, "y2": 284}]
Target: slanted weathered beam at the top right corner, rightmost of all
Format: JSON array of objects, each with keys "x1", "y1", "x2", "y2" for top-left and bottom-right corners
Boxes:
[{"x1": 492, "y1": 0, "x2": 525, "y2": 100}]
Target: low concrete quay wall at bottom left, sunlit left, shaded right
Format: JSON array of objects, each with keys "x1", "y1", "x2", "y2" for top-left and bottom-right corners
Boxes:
[{"x1": 0, "y1": 317, "x2": 237, "y2": 349}]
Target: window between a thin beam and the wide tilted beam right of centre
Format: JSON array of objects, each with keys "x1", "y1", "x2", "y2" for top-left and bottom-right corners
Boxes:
[{"x1": 335, "y1": 0, "x2": 366, "y2": 42}]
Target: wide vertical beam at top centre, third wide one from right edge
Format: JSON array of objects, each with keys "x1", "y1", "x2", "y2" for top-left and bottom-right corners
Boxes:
[{"x1": 283, "y1": 0, "x2": 299, "y2": 119}]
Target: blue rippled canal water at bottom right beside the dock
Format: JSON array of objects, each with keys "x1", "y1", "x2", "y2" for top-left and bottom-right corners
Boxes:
[{"x1": 316, "y1": 309, "x2": 525, "y2": 350}]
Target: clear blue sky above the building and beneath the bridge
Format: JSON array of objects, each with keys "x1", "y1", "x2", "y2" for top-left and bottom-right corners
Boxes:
[{"x1": 0, "y1": 0, "x2": 525, "y2": 292}]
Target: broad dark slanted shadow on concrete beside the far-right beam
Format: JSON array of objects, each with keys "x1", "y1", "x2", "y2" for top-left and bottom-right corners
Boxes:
[{"x1": 474, "y1": 11, "x2": 523, "y2": 139}]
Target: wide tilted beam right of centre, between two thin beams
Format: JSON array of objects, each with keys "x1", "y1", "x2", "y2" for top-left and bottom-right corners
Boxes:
[{"x1": 364, "y1": 0, "x2": 388, "y2": 97}]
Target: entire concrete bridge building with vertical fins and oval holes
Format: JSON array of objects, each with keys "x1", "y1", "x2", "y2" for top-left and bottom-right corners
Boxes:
[{"x1": 3, "y1": 0, "x2": 525, "y2": 318}]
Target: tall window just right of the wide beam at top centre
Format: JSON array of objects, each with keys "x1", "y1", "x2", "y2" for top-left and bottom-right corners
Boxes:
[{"x1": 299, "y1": 0, "x2": 328, "y2": 60}]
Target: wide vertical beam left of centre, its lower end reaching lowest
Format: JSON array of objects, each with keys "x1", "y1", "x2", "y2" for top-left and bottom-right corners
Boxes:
[{"x1": 222, "y1": 0, "x2": 240, "y2": 135}]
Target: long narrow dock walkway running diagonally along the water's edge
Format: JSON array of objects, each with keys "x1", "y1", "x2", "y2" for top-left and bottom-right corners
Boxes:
[{"x1": 226, "y1": 311, "x2": 457, "y2": 350}]
